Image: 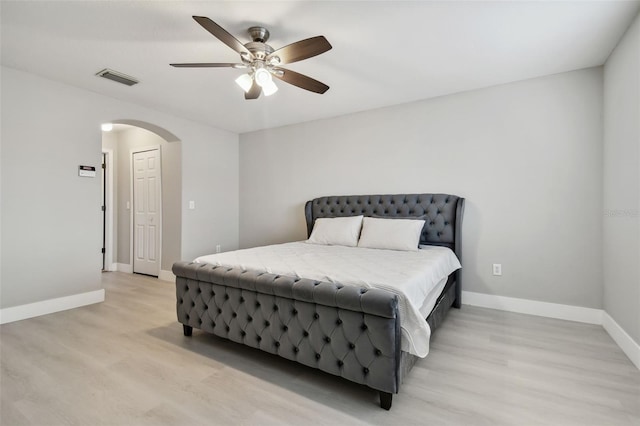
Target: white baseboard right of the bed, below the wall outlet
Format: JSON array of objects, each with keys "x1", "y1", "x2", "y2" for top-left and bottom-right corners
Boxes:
[{"x1": 462, "y1": 291, "x2": 604, "y2": 325}]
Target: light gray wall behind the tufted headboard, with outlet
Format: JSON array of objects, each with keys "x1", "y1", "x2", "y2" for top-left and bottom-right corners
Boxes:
[{"x1": 240, "y1": 68, "x2": 602, "y2": 308}]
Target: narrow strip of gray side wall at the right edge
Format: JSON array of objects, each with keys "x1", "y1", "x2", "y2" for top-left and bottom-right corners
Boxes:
[{"x1": 603, "y1": 13, "x2": 640, "y2": 344}]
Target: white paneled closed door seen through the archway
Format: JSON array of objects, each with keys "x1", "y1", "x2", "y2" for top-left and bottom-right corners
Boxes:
[{"x1": 133, "y1": 149, "x2": 162, "y2": 277}]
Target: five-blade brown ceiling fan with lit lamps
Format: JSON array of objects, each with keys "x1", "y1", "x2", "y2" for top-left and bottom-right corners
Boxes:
[{"x1": 170, "y1": 16, "x2": 331, "y2": 99}]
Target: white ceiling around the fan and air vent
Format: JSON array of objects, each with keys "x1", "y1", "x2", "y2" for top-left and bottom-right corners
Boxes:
[{"x1": 0, "y1": 0, "x2": 640, "y2": 133}]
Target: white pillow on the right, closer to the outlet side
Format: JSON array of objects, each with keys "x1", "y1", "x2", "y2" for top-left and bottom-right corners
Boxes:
[{"x1": 358, "y1": 217, "x2": 425, "y2": 251}]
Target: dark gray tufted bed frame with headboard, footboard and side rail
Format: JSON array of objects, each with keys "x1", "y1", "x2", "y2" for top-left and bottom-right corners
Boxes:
[{"x1": 173, "y1": 194, "x2": 464, "y2": 410}]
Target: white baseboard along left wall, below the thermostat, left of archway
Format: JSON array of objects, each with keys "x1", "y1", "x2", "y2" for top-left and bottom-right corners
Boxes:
[{"x1": 0, "y1": 289, "x2": 104, "y2": 324}]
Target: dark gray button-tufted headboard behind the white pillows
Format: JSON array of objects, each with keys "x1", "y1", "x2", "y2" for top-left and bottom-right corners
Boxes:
[{"x1": 304, "y1": 194, "x2": 464, "y2": 259}]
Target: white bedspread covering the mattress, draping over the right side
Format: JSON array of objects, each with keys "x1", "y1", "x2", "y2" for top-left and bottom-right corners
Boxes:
[{"x1": 195, "y1": 242, "x2": 460, "y2": 357}]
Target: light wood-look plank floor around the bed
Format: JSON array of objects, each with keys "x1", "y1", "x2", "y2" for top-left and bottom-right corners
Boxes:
[{"x1": 0, "y1": 272, "x2": 640, "y2": 425}]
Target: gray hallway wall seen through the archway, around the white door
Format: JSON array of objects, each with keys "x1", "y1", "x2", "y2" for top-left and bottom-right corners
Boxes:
[{"x1": 109, "y1": 127, "x2": 182, "y2": 271}]
